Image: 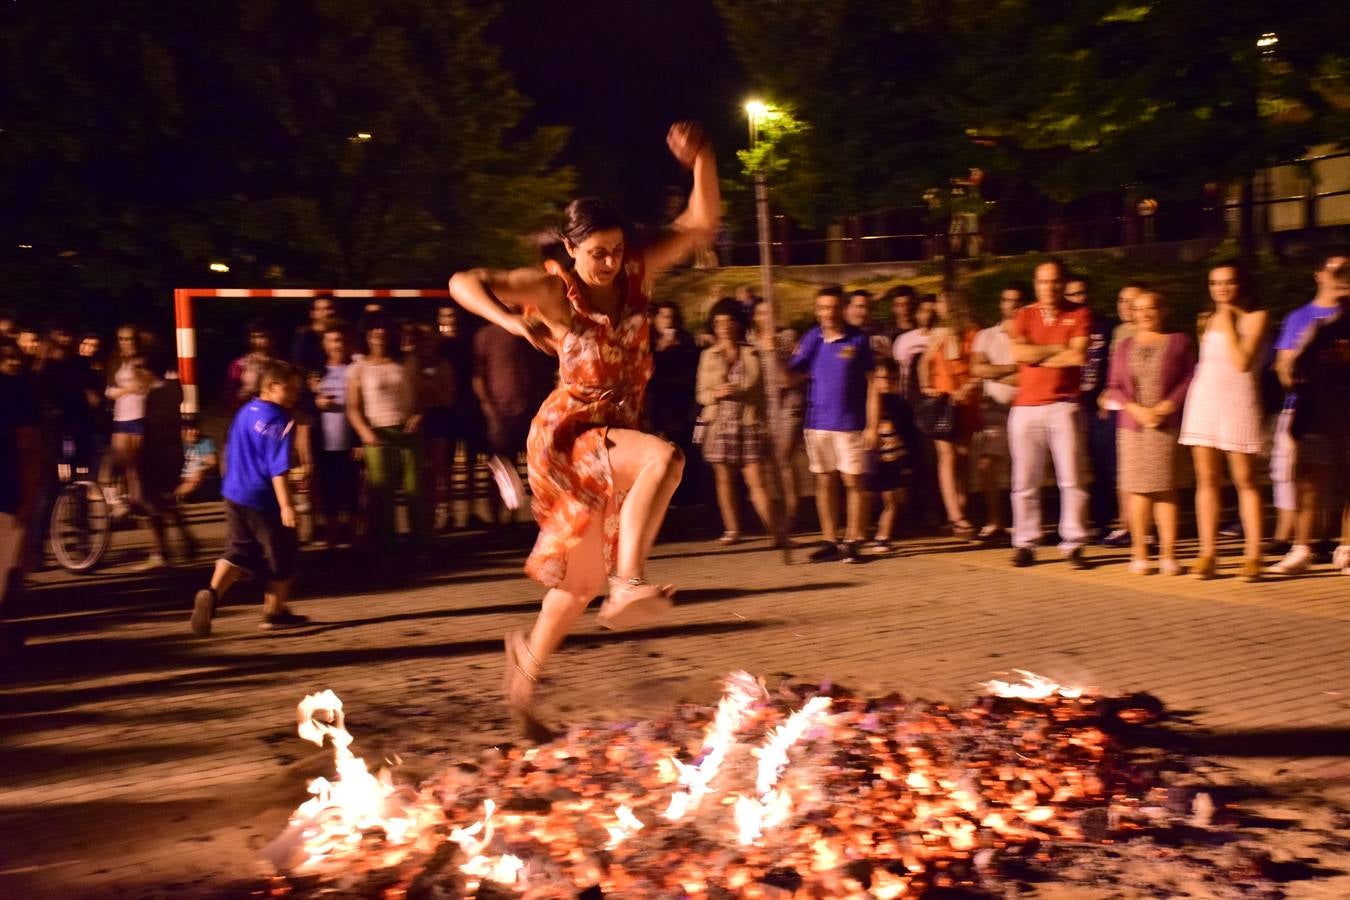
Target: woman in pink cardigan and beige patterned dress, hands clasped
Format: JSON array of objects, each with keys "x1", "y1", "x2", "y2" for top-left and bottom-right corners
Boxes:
[{"x1": 1102, "y1": 290, "x2": 1195, "y2": 575}]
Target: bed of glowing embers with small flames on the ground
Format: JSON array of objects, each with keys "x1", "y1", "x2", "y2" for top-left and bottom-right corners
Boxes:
[{"x1": 255, "y1": 672, "x2": 1236, "y2": 897}]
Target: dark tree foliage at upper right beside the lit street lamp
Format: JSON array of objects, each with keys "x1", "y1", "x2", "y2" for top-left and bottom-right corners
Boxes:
[{"x1": 718, "y1": 0, "x2": 1350, "y2": 216}]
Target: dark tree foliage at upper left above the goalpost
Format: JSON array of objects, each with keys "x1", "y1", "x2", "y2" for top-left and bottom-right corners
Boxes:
[{"x1": 0, "y1": 0, "x2": 571, "y2": 318}]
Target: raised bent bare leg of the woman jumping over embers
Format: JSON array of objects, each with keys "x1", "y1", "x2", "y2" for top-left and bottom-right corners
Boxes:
[{"x1": 608, "y1": 428, "x2": 684, "y2": 579}]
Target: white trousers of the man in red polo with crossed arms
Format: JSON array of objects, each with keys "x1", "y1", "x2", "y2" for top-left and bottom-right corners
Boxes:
[{"x1": 1008, "y1": 402, "x2": 1088, "y2": 553}]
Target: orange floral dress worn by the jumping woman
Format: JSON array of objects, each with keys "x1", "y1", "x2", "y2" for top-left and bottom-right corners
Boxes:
[{"x1": 525, "y1": 256, "x2": 652, "y2": 587}]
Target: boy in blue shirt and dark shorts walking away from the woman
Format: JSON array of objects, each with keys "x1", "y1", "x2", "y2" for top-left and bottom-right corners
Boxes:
[{"x1": 192, "y1": 360, "x2": 309, "y2": 637}]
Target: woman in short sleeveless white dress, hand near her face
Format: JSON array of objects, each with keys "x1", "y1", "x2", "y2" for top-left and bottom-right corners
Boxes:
[{"x1": 1180, "y1": 263, "x2": 1266, "y2": 582}]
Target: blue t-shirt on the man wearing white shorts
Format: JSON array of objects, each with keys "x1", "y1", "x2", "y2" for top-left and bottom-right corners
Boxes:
[{"x1": 788, "y1": 325, "x2": 873, "y2": 432}]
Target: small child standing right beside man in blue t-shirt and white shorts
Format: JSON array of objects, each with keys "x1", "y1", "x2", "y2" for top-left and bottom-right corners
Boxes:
[{"x1": 864, "y1": 356, "x2": 914, "y2": 553}]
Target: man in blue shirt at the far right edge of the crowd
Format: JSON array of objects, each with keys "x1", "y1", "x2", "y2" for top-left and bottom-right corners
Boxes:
[{"x1": 1270, "y1": 248, "x2": 1350, "y2": 575}]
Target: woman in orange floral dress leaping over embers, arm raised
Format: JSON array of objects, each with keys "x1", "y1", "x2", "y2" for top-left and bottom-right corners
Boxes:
[{"x1": 450, "y1": 123, "x2": 721, "y2": 737}]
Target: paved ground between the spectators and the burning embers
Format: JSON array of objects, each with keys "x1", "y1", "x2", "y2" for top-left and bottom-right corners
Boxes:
[{"x1": 0, "y1": 507, "x2": 1350, "y2": 897}]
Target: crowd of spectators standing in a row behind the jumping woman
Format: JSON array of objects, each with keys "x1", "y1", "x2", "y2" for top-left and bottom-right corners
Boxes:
[{"x1": 0, "y1": 251, "x2": 1350, "y2": 620}]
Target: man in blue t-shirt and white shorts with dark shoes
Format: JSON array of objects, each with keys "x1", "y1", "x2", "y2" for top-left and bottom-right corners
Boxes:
[{"x1": 788, "y1": 287, "x2": 876, "y2": 563}]
